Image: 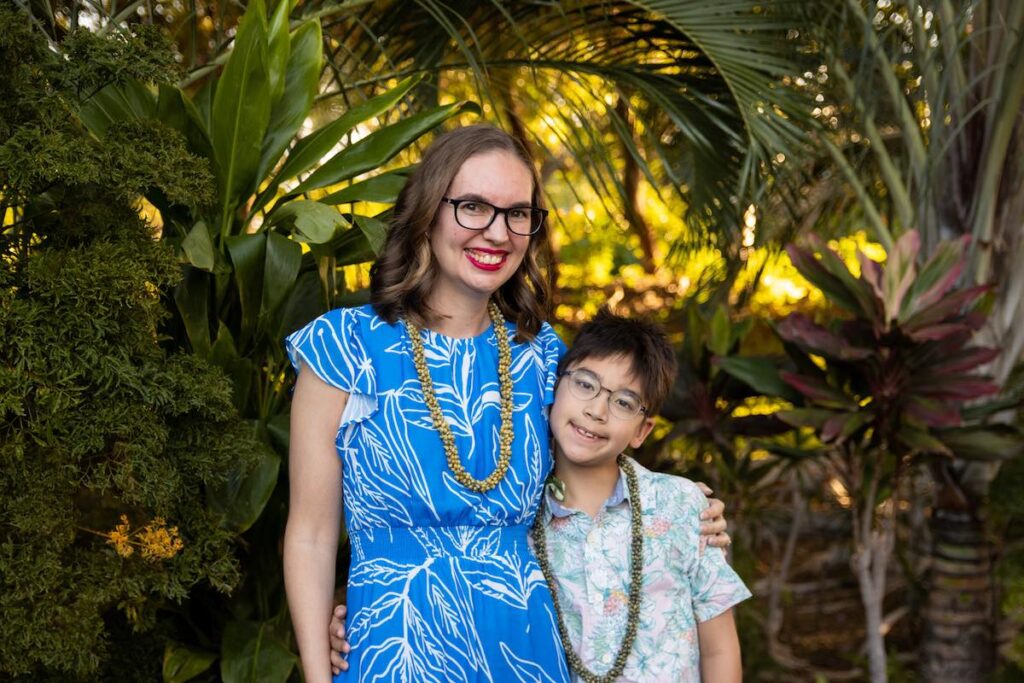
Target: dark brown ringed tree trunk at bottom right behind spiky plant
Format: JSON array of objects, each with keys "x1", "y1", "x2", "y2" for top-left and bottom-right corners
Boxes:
[{"x1": 921, "y1": 507, "x2": 995, "y2": 683}]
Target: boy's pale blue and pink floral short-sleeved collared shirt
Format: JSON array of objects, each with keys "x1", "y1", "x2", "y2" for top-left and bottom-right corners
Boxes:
[{"x1": 544, "y1": 461, "x2": 751, "y2": 683}]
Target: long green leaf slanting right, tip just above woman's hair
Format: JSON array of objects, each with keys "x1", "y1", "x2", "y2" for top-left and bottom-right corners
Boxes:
[{"x1": 293, "y1": 102, "x2": 479, "y2": 195}]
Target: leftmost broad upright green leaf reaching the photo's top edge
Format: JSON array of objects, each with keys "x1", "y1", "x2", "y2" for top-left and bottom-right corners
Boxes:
[{"x1": 210, "y1": 0, "x2": 270, "y2": 236}]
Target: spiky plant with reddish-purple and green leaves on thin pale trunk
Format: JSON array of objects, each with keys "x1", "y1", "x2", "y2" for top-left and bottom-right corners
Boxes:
[{"x1": 765, "y1": 231, "x2": 1022, "y2": 681}]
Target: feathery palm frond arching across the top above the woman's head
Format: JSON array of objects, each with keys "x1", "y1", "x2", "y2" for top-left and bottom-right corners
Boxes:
[{"x1": 299, "y1": 0, "x2": 809, "y2": 255}]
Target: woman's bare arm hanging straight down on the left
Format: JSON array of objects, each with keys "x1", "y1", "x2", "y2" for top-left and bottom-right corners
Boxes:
[{"x1": 285, "y1": 370, "x2": 348, "y2": 683}]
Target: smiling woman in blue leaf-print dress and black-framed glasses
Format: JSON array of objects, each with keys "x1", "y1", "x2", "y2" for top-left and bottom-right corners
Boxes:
[{"x1": 285, "y1": 126, "x2": 724, "y2": 683}]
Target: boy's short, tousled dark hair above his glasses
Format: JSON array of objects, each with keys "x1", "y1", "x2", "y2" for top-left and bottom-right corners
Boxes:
[{"x1": 558, "y1": 308, "x2": 678, "y2": 417}]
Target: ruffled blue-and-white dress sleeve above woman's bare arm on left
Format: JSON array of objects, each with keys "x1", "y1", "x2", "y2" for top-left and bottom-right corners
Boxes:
[{"x1": 285, "y1": 308, "x2": 377, "y2": 425}]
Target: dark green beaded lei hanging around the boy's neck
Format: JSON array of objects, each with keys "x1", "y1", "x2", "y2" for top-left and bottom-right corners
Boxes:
[{"x1": 532, "y1": 456, "x2": 643, "y2": 683}]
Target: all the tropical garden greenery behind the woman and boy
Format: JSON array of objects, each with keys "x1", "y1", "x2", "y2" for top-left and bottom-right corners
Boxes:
[{"x1": 0, "y1": 0, "x2": 1024, "y2": 682}]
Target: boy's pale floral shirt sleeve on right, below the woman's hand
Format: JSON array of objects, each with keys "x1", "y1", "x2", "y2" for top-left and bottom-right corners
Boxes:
[{"x1": 680, "y1": 479, "x2": 751, "y2": 624}]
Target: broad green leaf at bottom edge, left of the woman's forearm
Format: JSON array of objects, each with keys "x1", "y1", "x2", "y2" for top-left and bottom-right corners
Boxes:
[{"x1": 220, "y1": 622, "x2": 298, "y2": 683}]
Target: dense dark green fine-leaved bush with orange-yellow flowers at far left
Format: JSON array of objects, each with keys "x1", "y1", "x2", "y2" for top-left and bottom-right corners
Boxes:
[{"x1": 0, "y1": 7, "x2": 260, "y2": 680}]
